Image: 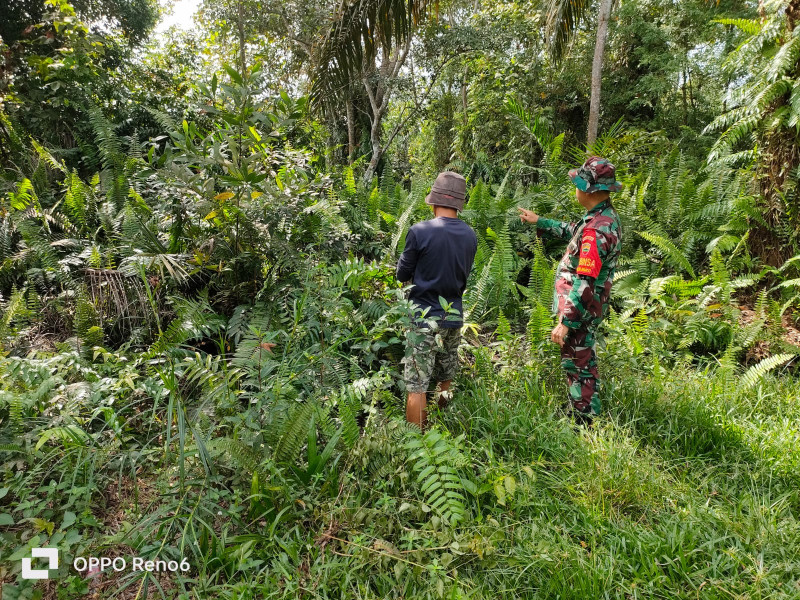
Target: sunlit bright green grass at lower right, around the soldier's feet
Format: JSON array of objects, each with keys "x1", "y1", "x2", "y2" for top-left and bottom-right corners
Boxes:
[{"x1": 192, "y1": 350, "x2": 800, "y2": 599}]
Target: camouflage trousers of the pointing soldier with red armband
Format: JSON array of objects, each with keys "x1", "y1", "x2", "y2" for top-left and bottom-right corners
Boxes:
[{"x1": 561, "y1": 328, "x2": 601, "y2": 415}]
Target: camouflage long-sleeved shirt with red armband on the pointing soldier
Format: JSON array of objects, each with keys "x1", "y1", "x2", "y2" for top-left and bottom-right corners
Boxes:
[{"x1": 536, "y1": 200, "x2": 622, "y2": 329}]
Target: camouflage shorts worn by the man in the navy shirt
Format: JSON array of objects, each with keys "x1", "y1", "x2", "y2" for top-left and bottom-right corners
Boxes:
[{"x1": 403, "y1": 327, "x2": 461, "y2": 394}]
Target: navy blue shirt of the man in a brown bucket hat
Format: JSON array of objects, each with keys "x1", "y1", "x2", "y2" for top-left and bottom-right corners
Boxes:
[{"x1": 397, "y1": 217, "x2": 478, "y2": 328}]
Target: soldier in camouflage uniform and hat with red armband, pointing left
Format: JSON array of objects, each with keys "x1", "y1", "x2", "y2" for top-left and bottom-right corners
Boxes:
[{"x1": 519, "y1": 156, "x2": 622, "y2": 424}]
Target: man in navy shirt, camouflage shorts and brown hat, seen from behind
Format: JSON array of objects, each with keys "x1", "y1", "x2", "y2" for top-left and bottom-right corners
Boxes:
[{"x1": 397, "y1": 171, "x2": 478, "y2": 429}]
